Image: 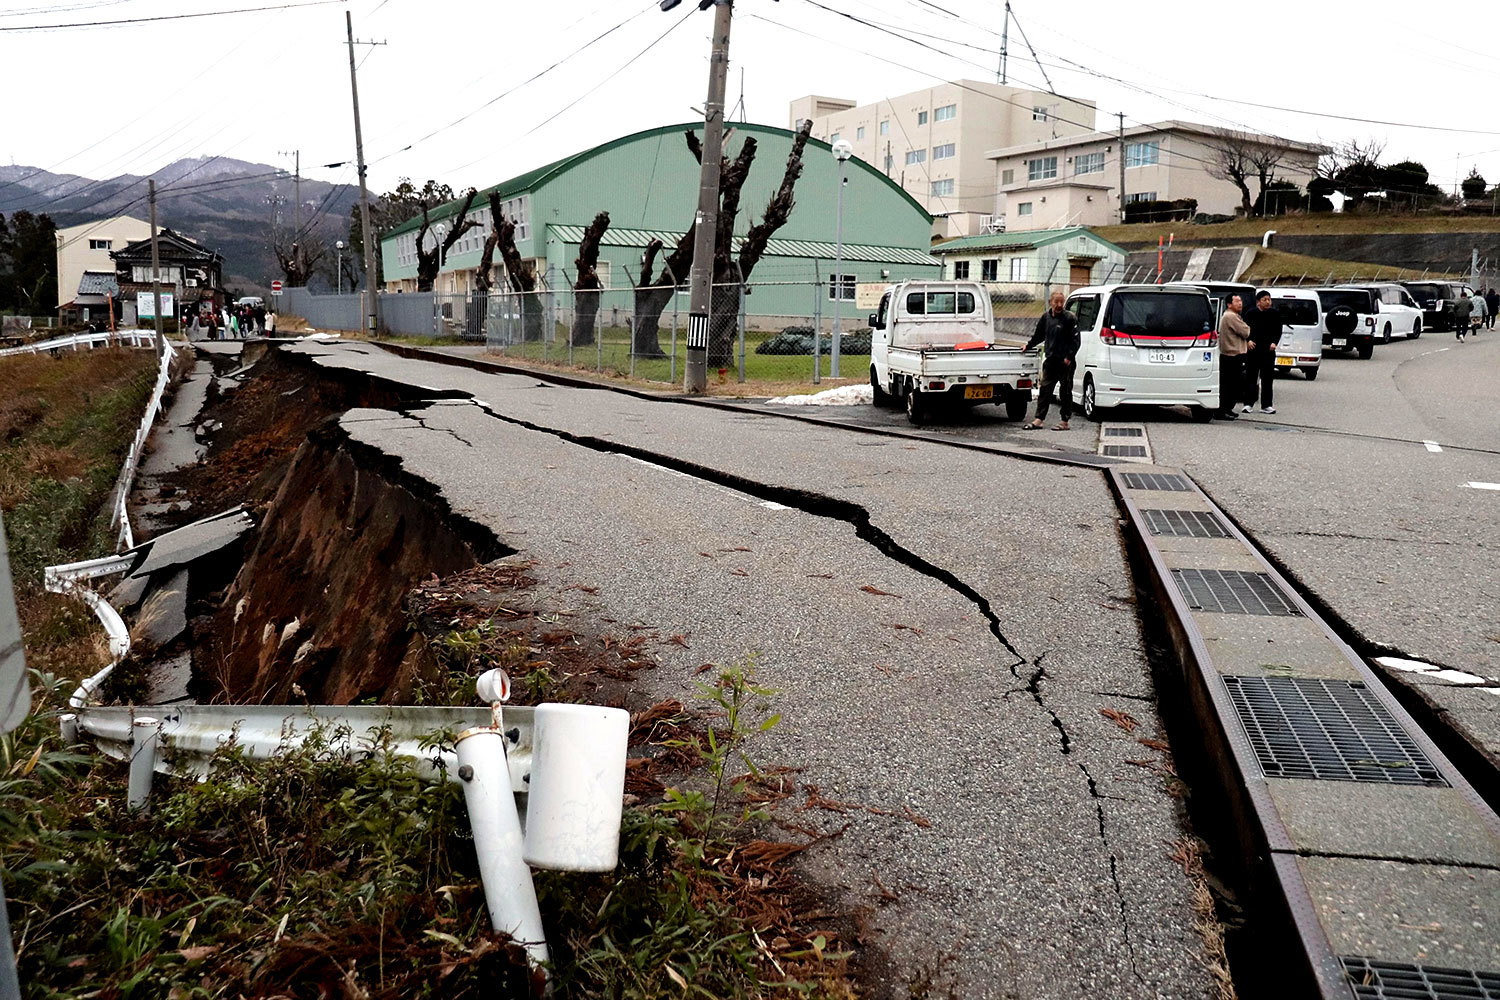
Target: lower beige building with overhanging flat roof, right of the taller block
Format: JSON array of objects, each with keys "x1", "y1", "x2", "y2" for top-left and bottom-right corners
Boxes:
[{"x1": 989, "y1": 121, "x2": 1328, "y2": 231}]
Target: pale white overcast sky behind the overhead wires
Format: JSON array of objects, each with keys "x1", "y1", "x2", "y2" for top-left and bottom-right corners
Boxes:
[{"x1": 0, "y1": 0, "x2": 1500, "y2": 203}]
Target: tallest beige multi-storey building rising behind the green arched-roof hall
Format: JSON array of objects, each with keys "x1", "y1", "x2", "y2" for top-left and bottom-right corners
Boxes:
[{"x1": 789, "y1": 79, "x2": 1095, "y2": 237}]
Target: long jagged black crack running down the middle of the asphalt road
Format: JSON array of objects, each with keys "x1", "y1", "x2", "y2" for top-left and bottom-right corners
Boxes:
[{"x1": 444, "y1": 399, "x2": 1146, "y2": 984}]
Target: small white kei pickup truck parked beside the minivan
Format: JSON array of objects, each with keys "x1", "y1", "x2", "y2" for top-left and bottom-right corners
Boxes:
[{"x1": 870, "y1": 280, "x2": 1038, "y2": 424}]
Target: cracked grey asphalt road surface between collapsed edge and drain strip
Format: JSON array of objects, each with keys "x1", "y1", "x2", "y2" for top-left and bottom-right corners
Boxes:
[{"x1": 293, "y1": 345, "x2": 1212, "y2": 999}]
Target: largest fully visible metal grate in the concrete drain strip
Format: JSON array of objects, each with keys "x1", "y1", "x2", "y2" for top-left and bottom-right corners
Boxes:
[{"x1": 1224, "y1": 676, "x2": 1446, "y2": 791}]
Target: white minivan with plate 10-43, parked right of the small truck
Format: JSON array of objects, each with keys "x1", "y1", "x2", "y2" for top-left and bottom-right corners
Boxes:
[{"x1": 1068, "y1": 285, "x2": 1220, "y2": 421}]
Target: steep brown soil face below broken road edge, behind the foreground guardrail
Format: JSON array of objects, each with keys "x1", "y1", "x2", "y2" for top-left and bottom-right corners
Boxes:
[{"x1": 207, "y1": 421, "x2": 506, "y2": 705}]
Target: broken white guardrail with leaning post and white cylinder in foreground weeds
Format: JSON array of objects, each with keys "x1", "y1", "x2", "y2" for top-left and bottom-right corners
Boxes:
[{"x1": 63, "y1": 672, "x2": 630, "y2": 966}]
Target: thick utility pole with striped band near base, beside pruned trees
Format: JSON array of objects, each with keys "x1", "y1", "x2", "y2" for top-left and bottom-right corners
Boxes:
[{"x1": 687, "y1": 0, "x2": 732, "y2": 394}]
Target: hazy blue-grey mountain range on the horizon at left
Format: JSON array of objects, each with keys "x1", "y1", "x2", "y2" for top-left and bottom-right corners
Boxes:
[{"x1": 0, "y1": 156, "x2": 359, "y2": 292}]
